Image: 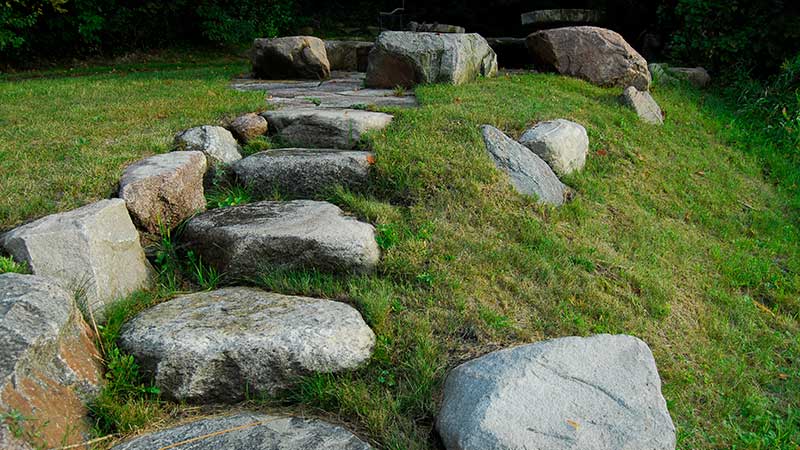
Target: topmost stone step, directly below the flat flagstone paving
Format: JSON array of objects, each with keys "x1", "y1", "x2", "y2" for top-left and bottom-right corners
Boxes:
[{"x1": 261, "y1": 108, "x2": 392, "y2": 150}]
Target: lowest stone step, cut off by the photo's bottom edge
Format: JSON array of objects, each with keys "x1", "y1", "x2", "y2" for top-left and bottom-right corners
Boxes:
[{"x1": 112, "y1": 412, "x2": 372, "y2": 450}]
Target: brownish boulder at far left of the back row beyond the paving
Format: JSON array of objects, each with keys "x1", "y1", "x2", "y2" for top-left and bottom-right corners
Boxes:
[{"x1": 250, "y1": 36, "x2": 331, "y2": 80}]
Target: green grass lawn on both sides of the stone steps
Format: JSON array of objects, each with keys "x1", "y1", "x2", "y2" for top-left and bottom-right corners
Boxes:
[{"x1": 0, "y1": 54, "x2": 800, "y2": 450}]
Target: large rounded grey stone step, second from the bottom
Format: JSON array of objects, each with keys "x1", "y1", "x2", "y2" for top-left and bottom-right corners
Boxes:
[{"x1": 120, "y1": 287, "x2": 375, "y2": 402}]
